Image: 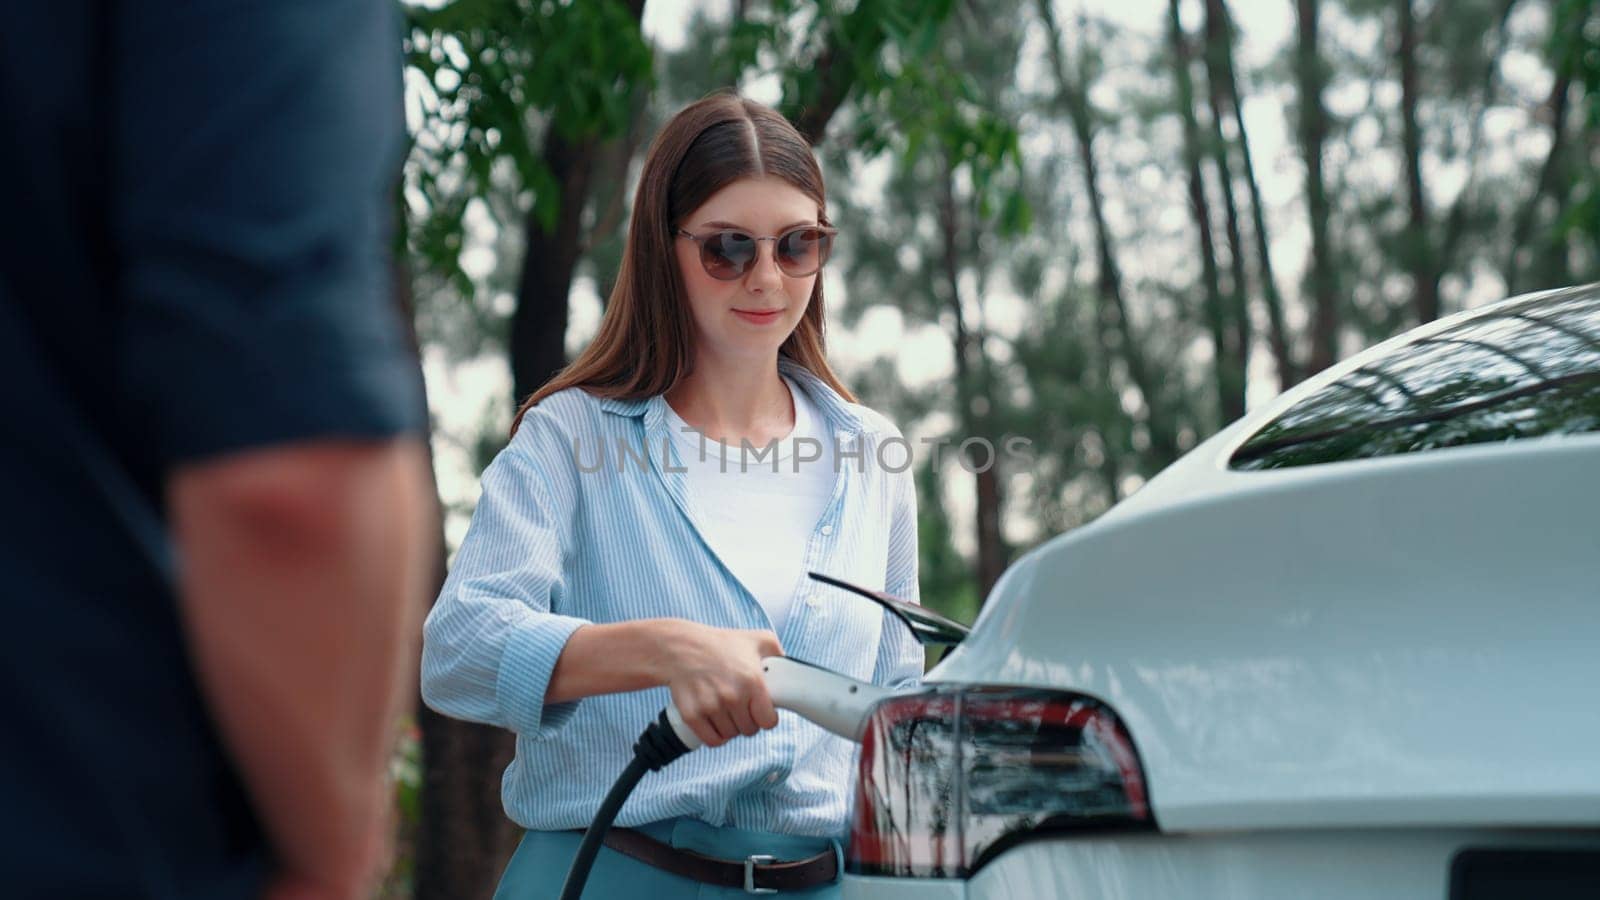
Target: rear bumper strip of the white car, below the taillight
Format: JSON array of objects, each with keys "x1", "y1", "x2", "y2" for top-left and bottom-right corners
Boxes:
[{"x1": 843, "y1": 828, "x2": 1600, "y2": 900}]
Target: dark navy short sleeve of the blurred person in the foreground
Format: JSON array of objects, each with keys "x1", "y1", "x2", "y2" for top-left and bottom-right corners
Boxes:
[{"x1": 104, "y1": 0, "x2": 427, "y2": 468}]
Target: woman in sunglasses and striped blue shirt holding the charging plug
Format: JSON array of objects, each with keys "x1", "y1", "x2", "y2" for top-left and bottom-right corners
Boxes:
[{"x1": 422, "y1": 94, "x2": 922, "y2": 900}]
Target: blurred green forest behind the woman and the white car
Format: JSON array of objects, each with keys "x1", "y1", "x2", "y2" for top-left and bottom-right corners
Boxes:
[{"x1": 381, "y1": 0, "x2": 1600, "y2": 900}]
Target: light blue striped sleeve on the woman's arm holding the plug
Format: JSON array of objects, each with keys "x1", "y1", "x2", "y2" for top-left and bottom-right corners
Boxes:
[{"x1": 422, "y1": 410, "x2": 589, "y2": 738}]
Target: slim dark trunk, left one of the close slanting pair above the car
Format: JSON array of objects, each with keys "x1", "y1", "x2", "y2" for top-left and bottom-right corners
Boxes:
[{"x1": 1166, "y1": 0, "x2": 1245, "y2": 424}]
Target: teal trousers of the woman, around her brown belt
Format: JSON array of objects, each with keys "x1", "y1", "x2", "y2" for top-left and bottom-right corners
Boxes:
[{"x1": 494, "y1": 818, "x2": 845, "y2": 900}]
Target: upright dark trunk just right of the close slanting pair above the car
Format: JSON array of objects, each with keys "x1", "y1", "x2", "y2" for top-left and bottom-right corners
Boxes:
[{"x1": 1294, "y1": 0, "x2": 1339, "y2": 375}]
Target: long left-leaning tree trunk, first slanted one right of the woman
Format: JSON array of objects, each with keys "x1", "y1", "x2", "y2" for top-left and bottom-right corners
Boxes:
[{"x1": 1038, "y1": 0, "x2": 1178, "y2": 469}]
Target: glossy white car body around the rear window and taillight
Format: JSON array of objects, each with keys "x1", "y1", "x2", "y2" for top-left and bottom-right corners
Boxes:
[{"x1": 845, "y1": 287, "x2": 1600, "y2": 900}]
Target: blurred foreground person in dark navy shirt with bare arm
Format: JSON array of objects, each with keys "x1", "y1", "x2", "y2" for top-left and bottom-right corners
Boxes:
[{"x1": 0, "y1": 0, "x2": 437, "y2": 900}]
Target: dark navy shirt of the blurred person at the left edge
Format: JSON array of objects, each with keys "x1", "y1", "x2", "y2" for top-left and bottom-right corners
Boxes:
[{"x1": 0, "y1": 0, "x2": 424, "y2": 900}]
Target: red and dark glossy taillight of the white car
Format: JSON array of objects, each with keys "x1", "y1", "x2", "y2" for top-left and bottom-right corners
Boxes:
[{"x1": 846, "y1": 687, "x2": 1155, "y2": 878}]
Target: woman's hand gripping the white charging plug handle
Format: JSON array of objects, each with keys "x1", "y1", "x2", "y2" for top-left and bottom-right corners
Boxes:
[{"x1": 661, "y1": 620, "x2": 784, "y2": 746}]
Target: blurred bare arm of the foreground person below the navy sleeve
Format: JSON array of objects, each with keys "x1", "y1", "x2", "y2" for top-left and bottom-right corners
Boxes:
[{"x1": 168, "y1": 440, "x2": 437, "y2": 900}]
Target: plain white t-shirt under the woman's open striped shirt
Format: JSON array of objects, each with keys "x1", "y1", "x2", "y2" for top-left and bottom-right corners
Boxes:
[{"x1": 667, "y1": 378, "x2": 837, "y2": 629}]
